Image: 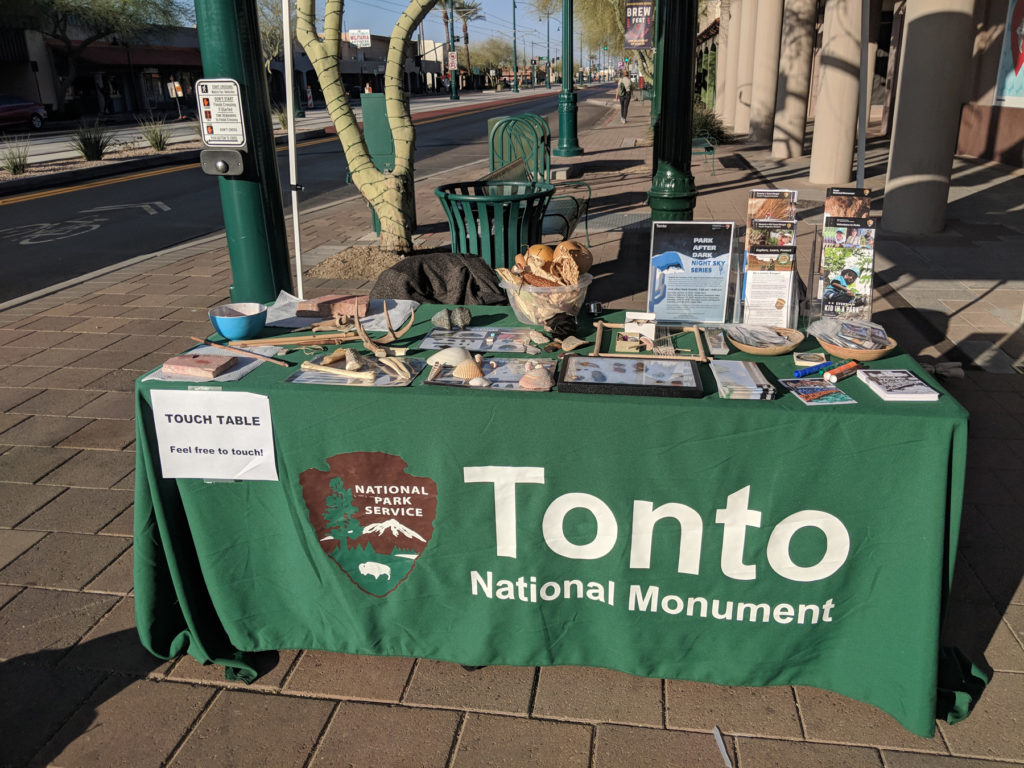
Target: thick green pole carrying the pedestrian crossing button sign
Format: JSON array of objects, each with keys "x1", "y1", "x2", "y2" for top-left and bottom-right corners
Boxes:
[{"x1": 196, "y1": 0, "x2": 292, "y2": 303}]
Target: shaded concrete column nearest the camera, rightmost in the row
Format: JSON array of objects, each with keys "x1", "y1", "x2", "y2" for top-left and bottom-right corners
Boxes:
[{"x1": 882, "y1": 0, "x2": 974, "y2": 234}]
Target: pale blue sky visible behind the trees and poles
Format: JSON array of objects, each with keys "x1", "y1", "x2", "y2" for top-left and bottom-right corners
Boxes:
[{"x1": 317, "y1": 0, "x2": 562, "y2": 57}]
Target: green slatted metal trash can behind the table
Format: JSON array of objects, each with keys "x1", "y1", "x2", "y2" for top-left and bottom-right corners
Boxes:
[{"x1": 434, "y1": 181, "x2": 555, "y2": 268}]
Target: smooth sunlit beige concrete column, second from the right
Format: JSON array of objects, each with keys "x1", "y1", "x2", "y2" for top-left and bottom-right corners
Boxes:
[{"x1": 809, "y1": 0, "x2": 863, "y2": 185}]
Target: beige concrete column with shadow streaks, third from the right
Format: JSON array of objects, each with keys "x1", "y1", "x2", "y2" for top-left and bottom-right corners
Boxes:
[{"x1": 771, "y1": 0, "x2": 817, "y2": 160}]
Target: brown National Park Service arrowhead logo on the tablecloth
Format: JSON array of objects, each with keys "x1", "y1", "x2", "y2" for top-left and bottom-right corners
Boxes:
[{"x1": 299, "y1": 452, "x2": 437, "y2": 597}]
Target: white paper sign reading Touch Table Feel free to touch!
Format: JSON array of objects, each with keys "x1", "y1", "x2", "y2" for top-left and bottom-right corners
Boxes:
[{"x1": 150, "y1": 389, "x2": 278, "y2": 480}]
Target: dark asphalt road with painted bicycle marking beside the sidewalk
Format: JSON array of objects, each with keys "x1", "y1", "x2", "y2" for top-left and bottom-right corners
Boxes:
[{"x1": 0, "y1": 89, "x2": 606, "y2": 302}]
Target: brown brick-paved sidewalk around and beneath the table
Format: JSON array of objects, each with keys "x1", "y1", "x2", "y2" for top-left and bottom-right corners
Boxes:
[{"x1": 0, "y1": 91, "x2": 1024, "y2": 768}]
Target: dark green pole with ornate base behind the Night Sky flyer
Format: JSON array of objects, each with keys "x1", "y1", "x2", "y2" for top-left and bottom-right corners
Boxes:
[{"x1": 647, "y1": 0, "x2": 697, "y2": 221}]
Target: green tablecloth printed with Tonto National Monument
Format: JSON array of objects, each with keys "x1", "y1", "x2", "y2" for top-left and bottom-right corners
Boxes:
[{"x1": 135, "y1": 306, "x2": 967, "y2": 735}]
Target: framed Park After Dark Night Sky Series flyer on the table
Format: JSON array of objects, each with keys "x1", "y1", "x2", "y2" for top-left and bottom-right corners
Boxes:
[{"x1": 647, "y1": 221, "x2": 733, "y2": 323}]
